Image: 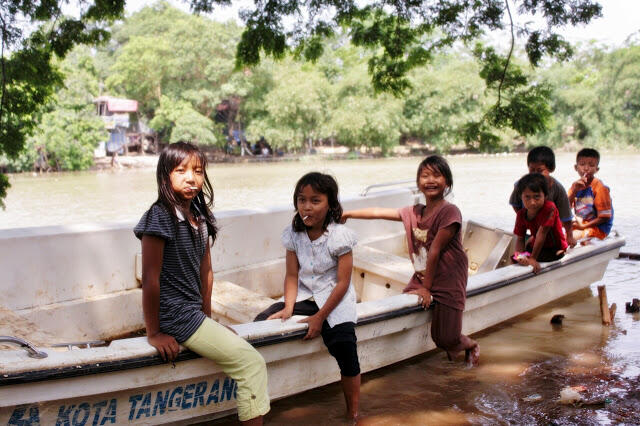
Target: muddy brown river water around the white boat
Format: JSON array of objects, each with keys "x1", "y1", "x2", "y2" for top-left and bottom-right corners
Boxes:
[{"x1": 0, "y1": 153, "x2": 640, "y2": 425}]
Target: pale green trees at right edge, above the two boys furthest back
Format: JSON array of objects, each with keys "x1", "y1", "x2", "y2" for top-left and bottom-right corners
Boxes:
[{"x1": 530, "y1": 45, "x2": 640, "y2": 147}]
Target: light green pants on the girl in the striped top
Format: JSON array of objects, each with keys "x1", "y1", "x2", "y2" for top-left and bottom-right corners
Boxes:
[{"x1": 183, "y1": 318, "x2": 270, "y2": 421}]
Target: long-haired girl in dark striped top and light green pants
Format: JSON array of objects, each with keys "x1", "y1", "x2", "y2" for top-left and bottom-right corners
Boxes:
[{"x1": 134, "y1": 142, "x2": 270, "y2": 425}]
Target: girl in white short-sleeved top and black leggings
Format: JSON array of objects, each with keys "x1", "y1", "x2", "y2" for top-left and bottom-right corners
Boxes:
[{"x1": 256, "y1": 172, "x2": 360, "y2": 419}]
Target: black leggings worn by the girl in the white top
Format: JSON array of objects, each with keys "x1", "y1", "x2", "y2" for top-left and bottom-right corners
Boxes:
[{"x1": 254, "y1": 300, "x2": 360, "y2": 377}]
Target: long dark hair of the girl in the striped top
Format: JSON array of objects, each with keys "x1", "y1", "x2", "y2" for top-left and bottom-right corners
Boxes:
[{"x1": 156, "y1": 141, "x2": 218, "y2": 244}]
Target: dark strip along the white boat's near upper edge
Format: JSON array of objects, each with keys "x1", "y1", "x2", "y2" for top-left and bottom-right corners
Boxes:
[{"x1": 0, "y1": 236, "x2": 625, "y2": 386}]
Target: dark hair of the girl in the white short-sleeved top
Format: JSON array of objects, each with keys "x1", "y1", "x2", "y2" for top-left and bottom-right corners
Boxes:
[{"x1": 291, "y1": 172, "x2": 342, "y2": 232}]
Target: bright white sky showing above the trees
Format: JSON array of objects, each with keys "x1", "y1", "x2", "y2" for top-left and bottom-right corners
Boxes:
[{"x1": 126, "y1": 0, "x2": 640, "y2": 47}]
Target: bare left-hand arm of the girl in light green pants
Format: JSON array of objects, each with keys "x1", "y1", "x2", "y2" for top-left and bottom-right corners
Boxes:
[{"x1": 142, "y1": 235, "x2": 180, "y2": 361}]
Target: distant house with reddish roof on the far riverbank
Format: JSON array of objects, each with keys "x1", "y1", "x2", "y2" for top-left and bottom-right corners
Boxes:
[{"x1": 93, "y1": 96, "x2": 155, "y2": 154}]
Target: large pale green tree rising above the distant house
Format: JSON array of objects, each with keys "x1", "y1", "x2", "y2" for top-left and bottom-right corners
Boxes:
[{"x1": 106, "y1": 2, "x2": 250, "y2": 126}]
